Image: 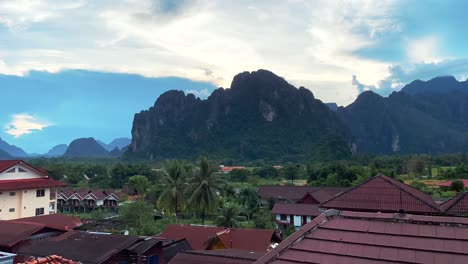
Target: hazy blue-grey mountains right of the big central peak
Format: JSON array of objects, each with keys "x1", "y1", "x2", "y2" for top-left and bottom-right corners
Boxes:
[{"x1": 337, "y1": 80, "x2": 468, "y2": 154}]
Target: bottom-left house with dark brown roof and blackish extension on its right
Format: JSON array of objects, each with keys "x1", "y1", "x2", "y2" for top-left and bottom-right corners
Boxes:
[{"x1": 17, "y1": 231, "x2": 191, "y2": 264}]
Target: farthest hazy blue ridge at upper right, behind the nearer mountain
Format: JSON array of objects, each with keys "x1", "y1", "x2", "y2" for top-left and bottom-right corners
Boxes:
[{"x1": 401, "y1": 76, "x2": 468, "y2": 95}]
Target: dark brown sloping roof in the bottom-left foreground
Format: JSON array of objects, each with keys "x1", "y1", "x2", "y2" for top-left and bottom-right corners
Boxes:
[{"x1": 18, "y1": 231, "x2": 139, "y2": 263}]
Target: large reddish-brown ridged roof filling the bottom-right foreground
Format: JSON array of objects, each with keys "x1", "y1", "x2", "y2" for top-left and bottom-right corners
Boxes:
[{"x1": 255, "y1": 210, "x2": 468, "y2": 264}]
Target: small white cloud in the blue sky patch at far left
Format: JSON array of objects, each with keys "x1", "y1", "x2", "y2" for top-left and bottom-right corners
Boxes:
[{"x1": 5, "y1": 114, "x2": 52, "y2": 138}]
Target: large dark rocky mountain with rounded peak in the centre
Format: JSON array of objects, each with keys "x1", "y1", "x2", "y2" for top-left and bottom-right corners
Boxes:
[{"x1": 127, "y1": 70, "x2": 350, "y2": 161}]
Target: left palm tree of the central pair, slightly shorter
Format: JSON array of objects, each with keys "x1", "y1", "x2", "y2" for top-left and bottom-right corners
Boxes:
[{"x1": 157, "y1": 160, "x2": 188, "y2": 218}]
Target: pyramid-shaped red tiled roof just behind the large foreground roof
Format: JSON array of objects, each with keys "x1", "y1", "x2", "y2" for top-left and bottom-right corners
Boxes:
[{"x1": 320, "y1": 174, "x2": 440, "y2": 214}]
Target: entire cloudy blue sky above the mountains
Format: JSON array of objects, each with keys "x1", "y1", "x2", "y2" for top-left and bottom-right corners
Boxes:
[{"x1": 0, "y1": 0, "x2": 468, "y2": 153}]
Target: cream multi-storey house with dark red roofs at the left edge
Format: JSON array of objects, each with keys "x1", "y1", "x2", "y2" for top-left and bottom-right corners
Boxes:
[{"x1": 0, "y1": 160, "x2": 66, "y2": 220}]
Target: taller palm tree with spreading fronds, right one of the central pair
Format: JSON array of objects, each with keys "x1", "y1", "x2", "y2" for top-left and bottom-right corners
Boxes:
[{"x1": 189, "y1": 157, "x2": 226, "y2": 225}]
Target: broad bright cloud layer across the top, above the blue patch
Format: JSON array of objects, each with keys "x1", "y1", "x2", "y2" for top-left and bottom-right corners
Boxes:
[{"x1": 0, "y1": 0, "x2": 468, "y2": 104}]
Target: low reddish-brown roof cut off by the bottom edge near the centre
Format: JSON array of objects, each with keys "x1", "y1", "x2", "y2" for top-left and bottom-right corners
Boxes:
[{"x1": 169, "y1": 248, "x2": 265, "y2": 264}]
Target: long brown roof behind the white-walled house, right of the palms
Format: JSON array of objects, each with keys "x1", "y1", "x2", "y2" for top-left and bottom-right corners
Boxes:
[{"x1": 258, "y1": 185, "x2": 348, "y2": 201}]
